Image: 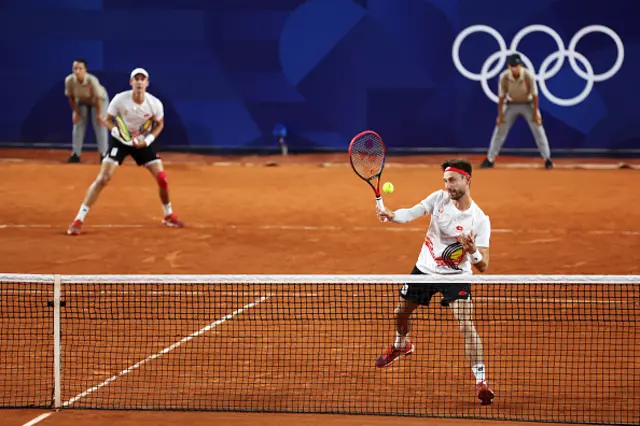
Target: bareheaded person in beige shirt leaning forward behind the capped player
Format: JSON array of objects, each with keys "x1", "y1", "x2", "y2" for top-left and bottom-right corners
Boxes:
[{"x1": 64, "y1": 59, "x2": 109, "y2": 163}]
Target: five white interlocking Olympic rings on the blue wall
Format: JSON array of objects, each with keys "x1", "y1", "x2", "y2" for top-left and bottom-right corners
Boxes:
[{"x1": 451, "y1": 25, "x2": 624, "y2": 107}]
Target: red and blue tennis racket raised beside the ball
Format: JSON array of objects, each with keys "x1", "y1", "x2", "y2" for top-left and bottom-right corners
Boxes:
[{"x1": 349, "y1": 130, "x2": 387, "y2": 210}]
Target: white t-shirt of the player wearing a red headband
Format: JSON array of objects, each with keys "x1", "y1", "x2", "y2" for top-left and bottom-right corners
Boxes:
[{"x1": 404, "y1": 190, "x2": 491, "y2": 274}]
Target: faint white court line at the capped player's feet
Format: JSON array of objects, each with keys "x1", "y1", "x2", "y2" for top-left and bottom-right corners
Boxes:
[{"x1": 0, "y1": 223, "x2": 640, "y2": 236}]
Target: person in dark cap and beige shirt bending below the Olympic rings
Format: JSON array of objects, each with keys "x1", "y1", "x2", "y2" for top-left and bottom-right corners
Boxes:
[{"x1": 480, "y1": 53, "x2": 553, "y2": 169}]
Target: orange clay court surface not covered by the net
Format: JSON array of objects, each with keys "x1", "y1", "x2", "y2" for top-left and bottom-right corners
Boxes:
[{"x1": 0, "y1": 150, "x2": 640, "y2": 426}]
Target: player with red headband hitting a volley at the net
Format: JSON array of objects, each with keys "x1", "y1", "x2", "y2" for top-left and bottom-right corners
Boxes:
[{"x1": 376, "y1": 160, "x2": 494, "y2": 405}]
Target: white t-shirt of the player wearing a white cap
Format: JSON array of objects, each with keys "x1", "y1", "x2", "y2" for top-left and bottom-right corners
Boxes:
[{"x1": 107, "y1": 90, "x2": 164, "y2": 137}]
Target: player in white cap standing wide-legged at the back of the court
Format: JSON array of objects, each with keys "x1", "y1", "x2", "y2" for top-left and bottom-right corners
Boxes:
[{"x1": 67, "y1": 68, "x2": 184, "y2": 235}]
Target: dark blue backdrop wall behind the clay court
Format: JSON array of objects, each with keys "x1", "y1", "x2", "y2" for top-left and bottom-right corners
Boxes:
[{"x1": 0, "y1": 0, "x2": 640, "y2": 152}]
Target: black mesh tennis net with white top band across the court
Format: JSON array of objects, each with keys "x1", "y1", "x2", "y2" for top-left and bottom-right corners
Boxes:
[{"x1": 0, "y1": 274, "x2": 640, "y2": 424}]
